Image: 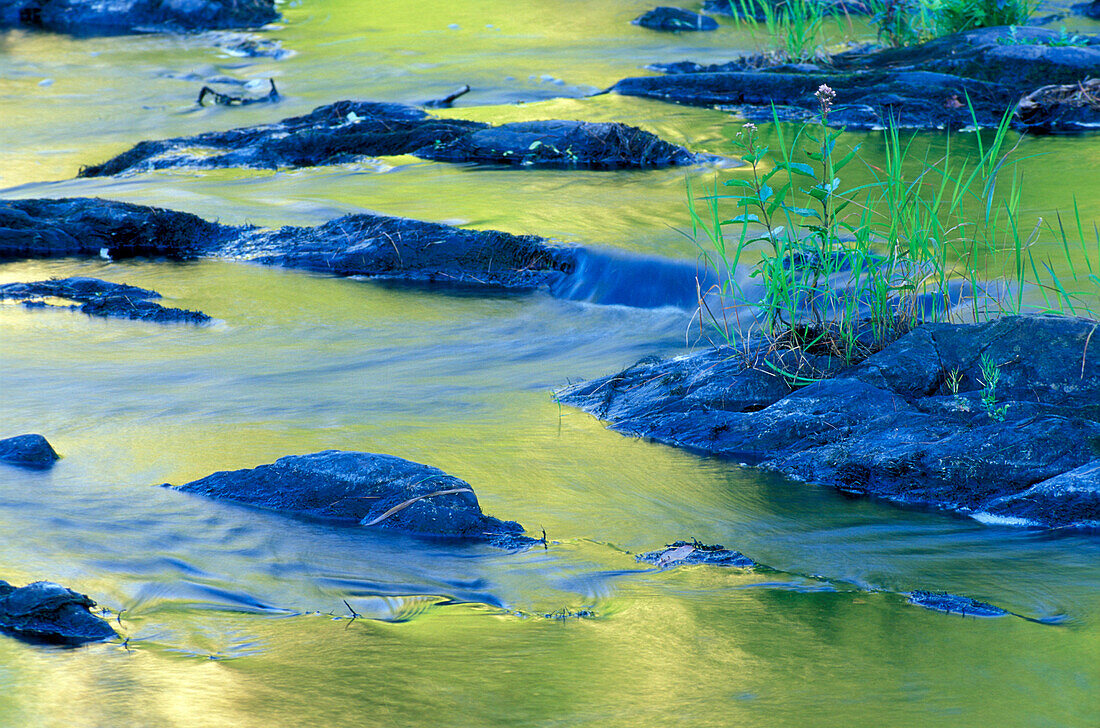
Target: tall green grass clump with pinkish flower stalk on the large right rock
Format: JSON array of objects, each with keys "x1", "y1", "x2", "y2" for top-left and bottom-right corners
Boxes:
[{"x1": 689, "y1": 86, "x2": 1100, "y2": 362}]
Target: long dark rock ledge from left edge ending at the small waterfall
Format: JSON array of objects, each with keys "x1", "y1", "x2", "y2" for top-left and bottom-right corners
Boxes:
[{"x1": 0, "y1": 198, "x2": 576, "y2": 294}]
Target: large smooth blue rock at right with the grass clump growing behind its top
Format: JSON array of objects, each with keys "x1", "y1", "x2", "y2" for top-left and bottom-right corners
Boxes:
[{"x1": 556, "y1": 316, "x2": 1100, "y2": 530}]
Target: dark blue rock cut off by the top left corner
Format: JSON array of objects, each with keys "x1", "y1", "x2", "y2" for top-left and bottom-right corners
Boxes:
[{"x1": 0, "y1": 0, "x2": 278, "y2": 35}]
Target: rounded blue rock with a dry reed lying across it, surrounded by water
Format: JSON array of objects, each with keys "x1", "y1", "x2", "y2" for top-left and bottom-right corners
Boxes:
[{"x1": 166, "y1": 450, "x2": 536, "y2": 549}]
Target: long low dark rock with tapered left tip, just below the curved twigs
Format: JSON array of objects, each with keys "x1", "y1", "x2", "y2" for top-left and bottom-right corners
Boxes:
[{"x1": 78, "y1": 101, "x2": 701, "y2": 177}]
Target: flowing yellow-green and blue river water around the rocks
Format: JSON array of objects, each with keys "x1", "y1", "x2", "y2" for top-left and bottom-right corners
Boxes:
[{"x1": 0, "y1": 0, "x2": 1100, "y2": 727}]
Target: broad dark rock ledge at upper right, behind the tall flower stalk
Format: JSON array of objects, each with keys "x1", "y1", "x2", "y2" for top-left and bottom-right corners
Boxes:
[{"x1": 609, "y1": 27, "x2": 1100, "y2": 133}]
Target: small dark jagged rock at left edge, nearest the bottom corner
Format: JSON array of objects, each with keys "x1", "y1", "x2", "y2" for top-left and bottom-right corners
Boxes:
[{"x1": 0, "y1": 581, "x2": 117, "y2": 644}]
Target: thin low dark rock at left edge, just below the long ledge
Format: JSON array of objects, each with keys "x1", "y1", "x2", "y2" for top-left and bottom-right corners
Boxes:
[{"x1": 0, "y1": 277, "x2": 211, "y2": 324}]
